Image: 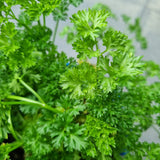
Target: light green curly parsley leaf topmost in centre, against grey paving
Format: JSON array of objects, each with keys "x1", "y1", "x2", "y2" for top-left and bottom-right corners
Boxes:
[{"x1": 71, "y1": 9, "x2": 109, "y2": 41}]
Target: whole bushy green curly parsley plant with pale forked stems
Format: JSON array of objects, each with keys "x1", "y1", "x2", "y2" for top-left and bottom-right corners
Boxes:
[{"x1": 0, "y1": 0, "x2": 160, "y2": 160}]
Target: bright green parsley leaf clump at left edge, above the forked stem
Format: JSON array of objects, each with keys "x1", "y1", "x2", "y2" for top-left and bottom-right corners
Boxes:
[{"x1": 0, "y1": 22, "x2": 40, "y2": 70}]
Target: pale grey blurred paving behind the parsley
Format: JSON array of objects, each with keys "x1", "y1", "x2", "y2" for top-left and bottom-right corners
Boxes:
[{"x1": 13, "y1": 0, "x2": 160, "y2": 143}]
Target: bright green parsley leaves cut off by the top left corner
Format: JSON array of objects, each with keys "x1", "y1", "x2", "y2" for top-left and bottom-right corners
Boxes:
[{"x1": 0, "y1": 0, "x2": 61, "y2": 22}]
